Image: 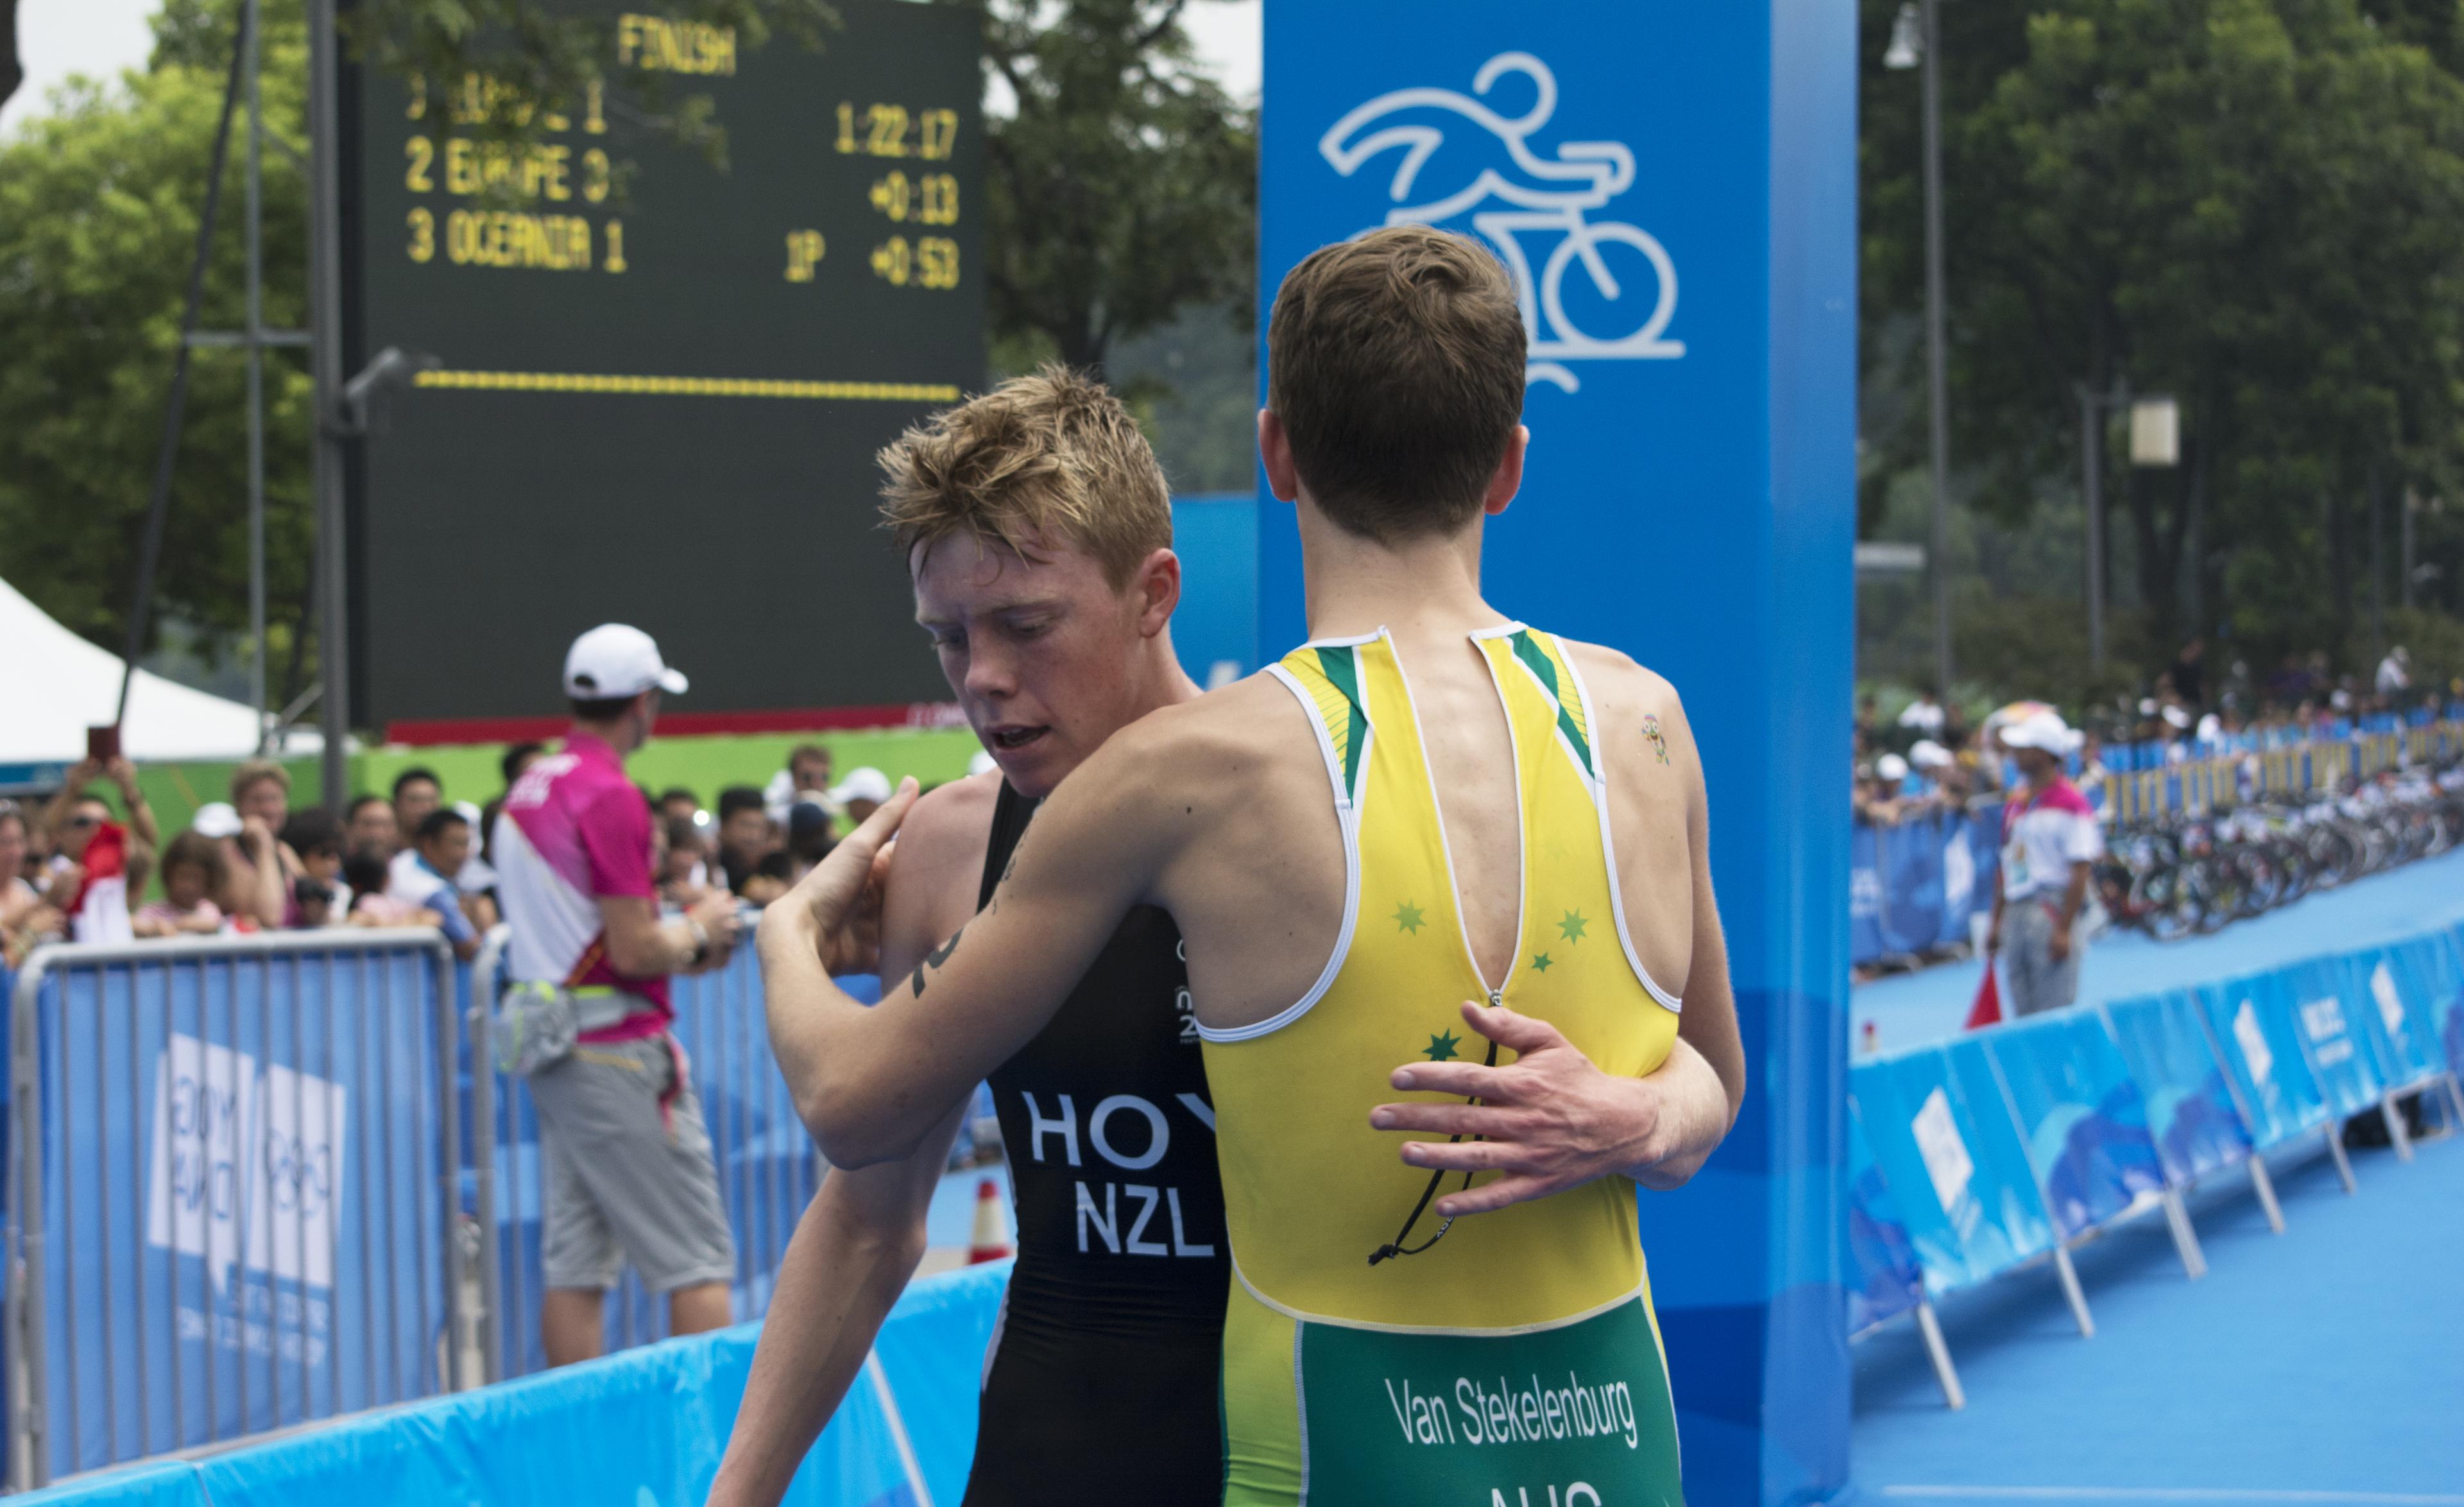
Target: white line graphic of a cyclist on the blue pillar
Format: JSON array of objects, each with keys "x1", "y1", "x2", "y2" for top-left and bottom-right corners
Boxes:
[{"x1": 1318, "y1": 52, "x2": 1686, "y2": 392}]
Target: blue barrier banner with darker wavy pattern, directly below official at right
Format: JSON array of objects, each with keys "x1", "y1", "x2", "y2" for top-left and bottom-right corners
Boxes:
[{"x1": 1974, "y1": 1012, "x2": 2164, "y2": 1236}]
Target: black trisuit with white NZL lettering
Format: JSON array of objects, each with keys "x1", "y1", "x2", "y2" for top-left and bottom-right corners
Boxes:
[{"x1": 966, "y1": 784, "x2": 1232, "y2": 1507}]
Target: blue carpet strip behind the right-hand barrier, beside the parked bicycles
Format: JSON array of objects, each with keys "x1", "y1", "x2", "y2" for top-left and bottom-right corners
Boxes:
[{"x1": 1848, "y1": 848, "x2": 2464, "y2": 1051}]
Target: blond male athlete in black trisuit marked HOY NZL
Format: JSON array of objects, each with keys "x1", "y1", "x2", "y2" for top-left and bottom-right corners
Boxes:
[{"x1": 710, "y1": 372, "x2": 1229, "y2": 1507}]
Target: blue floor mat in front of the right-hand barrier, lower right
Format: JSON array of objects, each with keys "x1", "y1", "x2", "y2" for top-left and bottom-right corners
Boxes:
[{"x1": 1851, "y1": 1137, "x2": 2464, "y2": 1507}]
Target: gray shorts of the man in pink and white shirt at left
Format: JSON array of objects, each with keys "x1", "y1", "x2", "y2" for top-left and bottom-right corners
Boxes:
[{"x1": 530, "y1": 1036, "x2": 737, "y2": 1293}]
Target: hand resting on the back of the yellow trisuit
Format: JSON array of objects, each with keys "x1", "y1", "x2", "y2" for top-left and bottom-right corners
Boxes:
[{"x1": 1370, "y1": 1001, "x2": 1695, "y2": 1218}]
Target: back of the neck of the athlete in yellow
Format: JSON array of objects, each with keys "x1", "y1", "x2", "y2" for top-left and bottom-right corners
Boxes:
[{"x1": 1296, "y1": 491, "x2": 1505, "y2": 639}]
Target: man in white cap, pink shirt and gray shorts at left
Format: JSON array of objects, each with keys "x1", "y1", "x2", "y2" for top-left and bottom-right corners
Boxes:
[{"x1": 495, "y1": 624, "x2": 737, "y2": 1366}]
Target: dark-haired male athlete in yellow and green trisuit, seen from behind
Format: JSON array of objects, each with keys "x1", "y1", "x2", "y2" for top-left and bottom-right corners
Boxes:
[{"x1": 762, "y1": 227, "x2": 1745, "y2": 1507}]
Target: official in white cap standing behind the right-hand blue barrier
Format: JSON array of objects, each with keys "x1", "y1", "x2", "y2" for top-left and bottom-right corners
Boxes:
[{"x1": 1986, "y1": 710, "x2": 2104, "y2": 1016}]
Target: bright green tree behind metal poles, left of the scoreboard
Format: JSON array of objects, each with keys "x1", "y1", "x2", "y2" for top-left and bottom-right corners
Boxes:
[{"x1": 0, "y1": 8, "x2": 311, "y2": 649}]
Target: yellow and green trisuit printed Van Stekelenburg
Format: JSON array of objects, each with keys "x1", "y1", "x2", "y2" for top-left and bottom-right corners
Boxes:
[{"x1": 1200, "y1": 624, "x2": 1683, "y2": 1507}]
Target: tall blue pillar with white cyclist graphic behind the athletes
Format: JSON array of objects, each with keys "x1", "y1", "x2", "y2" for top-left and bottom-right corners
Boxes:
[{"x1": 1259, "y1": 0, "x2": 1856, "y2": 1507}]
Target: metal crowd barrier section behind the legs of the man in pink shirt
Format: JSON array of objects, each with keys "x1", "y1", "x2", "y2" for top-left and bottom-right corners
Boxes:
[{"x1": 463, "y1": 927, "x2": 823, "y2": 1381}]
